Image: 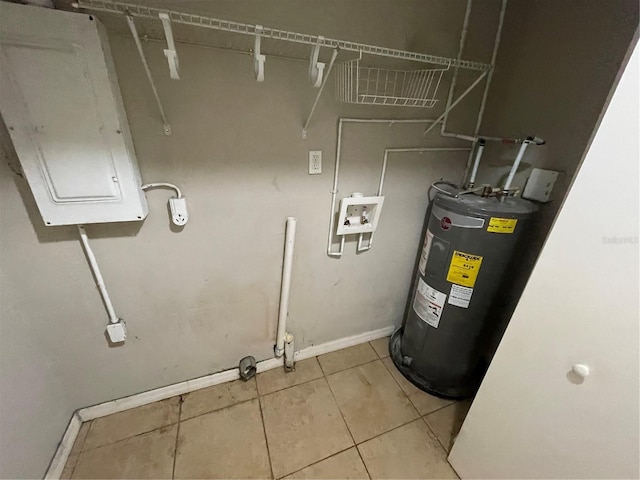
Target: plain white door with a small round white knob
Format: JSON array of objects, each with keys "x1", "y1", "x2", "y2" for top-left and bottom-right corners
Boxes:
[{"x1": 449, "y1": 40, "x2": 640, "y2": 478}]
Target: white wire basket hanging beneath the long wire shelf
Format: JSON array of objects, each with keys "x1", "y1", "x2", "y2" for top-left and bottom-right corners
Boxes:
[{"x1": 335, "y1": 58, "x2": 449, "y2": 108}]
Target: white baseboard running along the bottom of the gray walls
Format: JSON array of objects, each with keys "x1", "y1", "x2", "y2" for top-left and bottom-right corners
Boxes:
[{"x1": 44, "y1": 326, "x2": 396, "y2": 479}]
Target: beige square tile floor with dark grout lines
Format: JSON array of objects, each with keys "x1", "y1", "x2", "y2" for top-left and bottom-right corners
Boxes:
[{"x1": 62, "y1": 338, "x2": 469, "y2": 479}]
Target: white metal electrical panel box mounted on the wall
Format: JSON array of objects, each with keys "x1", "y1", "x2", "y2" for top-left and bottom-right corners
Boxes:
[{"x1": 0, "y1": 1, "x2": 147, "y2": 225}]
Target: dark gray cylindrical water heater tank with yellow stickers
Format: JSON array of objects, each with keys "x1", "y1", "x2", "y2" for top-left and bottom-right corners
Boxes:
[{"x1": 389, "y1": 193, "x2": 537, "y2": 398}]
